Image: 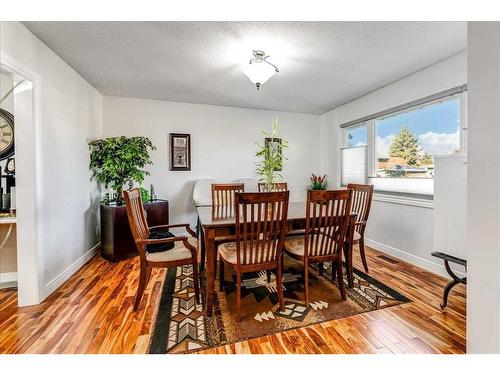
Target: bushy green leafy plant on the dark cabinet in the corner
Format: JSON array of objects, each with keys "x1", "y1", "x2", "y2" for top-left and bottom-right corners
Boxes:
[{"x1": 89, "y1": 136, "x2": 156, "y2": 204}]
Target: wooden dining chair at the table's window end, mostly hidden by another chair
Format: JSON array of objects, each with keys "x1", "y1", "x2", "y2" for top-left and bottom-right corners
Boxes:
[{"x1": 347, "y1": 184, "x2": 373, "y2": 273}]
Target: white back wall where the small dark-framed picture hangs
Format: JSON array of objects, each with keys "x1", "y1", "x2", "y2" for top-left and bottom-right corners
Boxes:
[{"x1": 104, "y1": 96, "x2": 321, "y2": 225}]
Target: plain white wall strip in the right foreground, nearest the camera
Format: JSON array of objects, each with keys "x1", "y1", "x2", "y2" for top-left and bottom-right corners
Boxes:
[{"x1": 467, "y1": 22, "x2": 500, "y2": 353}]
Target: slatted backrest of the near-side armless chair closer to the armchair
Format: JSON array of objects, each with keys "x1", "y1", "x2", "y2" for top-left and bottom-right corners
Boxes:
[{"x1": 235, "y1": 191, "x2": 289, "y2": 267}]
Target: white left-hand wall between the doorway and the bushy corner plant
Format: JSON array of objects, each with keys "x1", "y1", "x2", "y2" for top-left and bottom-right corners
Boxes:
[{"x1": 0, "y1": 22, "x2": 102, "y2": 299}]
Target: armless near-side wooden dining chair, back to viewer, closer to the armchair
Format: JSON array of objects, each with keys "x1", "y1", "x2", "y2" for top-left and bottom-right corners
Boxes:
[{"x1": 219, "y1": 191, "x2": 289, "y2": 321}]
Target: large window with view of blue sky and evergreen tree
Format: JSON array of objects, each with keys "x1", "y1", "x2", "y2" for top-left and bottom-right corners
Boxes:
[{"x1": 341, "y1": 90, "x2": 465, "y2": 197}]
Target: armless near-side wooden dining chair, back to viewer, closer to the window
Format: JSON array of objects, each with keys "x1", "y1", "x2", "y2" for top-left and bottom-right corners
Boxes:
[{"x1": 283, "y1": 190, "x2": 352, "y2": 306}]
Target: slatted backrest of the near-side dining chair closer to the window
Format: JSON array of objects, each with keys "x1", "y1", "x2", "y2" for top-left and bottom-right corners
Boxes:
[{"x1": 304, "y1": 190, "x2": 352, "y2": 257}]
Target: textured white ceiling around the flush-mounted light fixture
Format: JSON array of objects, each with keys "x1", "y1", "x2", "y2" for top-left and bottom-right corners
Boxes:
[{"x1": 24, "y1": 22, "x2": 467, "y2": 114}]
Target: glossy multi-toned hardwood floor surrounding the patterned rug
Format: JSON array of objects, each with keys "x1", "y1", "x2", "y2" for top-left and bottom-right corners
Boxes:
[{"x1": 0, "y1": 249, "x2": 466, "y2": 353}]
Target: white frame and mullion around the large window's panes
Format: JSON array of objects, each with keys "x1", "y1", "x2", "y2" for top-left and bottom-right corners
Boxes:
[{"x1": 339, "y1": 85, "x2": 467, "y2": 203}]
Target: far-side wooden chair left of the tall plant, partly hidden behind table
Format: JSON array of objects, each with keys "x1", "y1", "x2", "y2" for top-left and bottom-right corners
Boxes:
[{"x1": 200, "y1": 182, "x2": 245, "y2": 270}]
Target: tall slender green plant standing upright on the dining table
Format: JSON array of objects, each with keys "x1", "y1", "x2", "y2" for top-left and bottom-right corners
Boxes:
[{"x1": 255, "y1": 116, "x2": 288, "y2": 191}]
